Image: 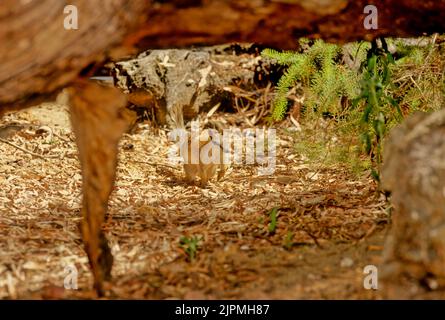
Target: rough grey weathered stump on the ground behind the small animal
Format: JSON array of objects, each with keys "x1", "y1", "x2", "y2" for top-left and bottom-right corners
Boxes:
[{"x1": 113, "y1": 46, "x2": 270, "y2": 128}]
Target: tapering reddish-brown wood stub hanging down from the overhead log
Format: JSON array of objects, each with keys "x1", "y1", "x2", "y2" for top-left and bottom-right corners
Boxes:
[{"x1": 69, "y1": 82, "x2": 127, "y2": 294}]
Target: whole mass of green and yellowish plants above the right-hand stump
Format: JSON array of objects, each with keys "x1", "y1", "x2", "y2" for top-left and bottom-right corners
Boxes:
[{"x1": 262, "y1": 36, "x2": 445, "y2": 181}]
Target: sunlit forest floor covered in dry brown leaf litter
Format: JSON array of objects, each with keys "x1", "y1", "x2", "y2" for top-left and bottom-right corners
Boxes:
[{"x1": 0, "y1": 101, "x2": 444, "y2": 299}]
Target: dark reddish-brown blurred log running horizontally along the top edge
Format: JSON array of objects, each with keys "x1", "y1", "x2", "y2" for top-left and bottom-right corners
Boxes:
[{"x1": 123, "y1": 0, "x2": 445, "y2": 48}]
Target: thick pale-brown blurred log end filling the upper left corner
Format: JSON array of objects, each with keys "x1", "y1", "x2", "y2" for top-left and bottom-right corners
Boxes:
[{"x1": 0, "y1": 0, "x2": 145, "y2": 114}]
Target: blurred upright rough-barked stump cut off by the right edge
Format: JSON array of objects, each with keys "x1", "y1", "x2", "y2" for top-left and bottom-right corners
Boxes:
[{"x1": 382, "y1": 109, "x2": 445, "y2": 289}]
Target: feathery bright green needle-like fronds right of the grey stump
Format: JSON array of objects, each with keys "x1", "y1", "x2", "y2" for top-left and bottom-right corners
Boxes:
[{"x1": 262, "y1": 39, "x2": 359, "y2": 121}]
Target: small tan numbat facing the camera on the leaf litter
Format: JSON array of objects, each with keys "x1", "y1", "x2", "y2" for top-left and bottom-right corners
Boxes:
[{"x1": 181, "y1": 130, "x2": 225, "y2": 187}]
